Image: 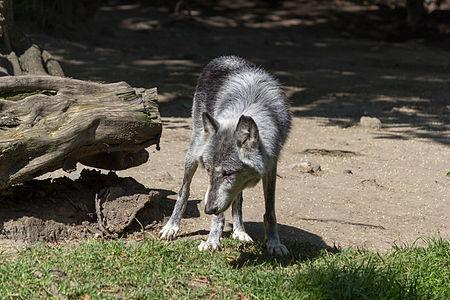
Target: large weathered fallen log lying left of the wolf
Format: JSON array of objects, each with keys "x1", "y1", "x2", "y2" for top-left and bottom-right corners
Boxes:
[{"x1": 0, "y1": 76, "x2": 162, "y2": 189}]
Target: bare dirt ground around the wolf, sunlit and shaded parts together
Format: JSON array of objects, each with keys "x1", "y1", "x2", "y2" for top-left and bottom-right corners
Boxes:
[{"x1": 0, "y1": 0, "x2": 450, "y2": 250}]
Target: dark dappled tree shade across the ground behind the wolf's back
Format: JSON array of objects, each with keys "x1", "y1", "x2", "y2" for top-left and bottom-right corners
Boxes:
[{"x1": 26, "y1": 0, "x2": 450, "y2": 145}]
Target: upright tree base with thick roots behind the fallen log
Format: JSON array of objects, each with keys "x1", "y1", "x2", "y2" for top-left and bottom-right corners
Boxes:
[{"x1": 0, "y1": 0, "x2": 64, "y2": 76}]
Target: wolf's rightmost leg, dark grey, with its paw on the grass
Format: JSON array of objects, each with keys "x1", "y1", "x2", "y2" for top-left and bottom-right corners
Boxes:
[{"x1": 263, "y1": 163, "x2": 289, "y2": 256}]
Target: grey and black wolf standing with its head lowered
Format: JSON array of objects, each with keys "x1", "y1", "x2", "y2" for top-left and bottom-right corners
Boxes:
[{"x1": 160, "y1": 56, "x2": 291, "y2": 256}]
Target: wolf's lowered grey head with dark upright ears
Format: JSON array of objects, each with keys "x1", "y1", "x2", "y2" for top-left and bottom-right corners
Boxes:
[{"x1": 201, "y1": 113, "x2": 266, "y2": 214}]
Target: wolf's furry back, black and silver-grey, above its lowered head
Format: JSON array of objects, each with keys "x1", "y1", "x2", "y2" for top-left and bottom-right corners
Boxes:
[{"x1": 192, "y1": 56, "x2": 291, "y2": 157}]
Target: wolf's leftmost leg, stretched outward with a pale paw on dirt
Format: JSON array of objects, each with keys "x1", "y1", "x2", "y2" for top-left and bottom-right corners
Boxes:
[{"x1": 159, "y1": 146, "x2": 198, "y2": 240}]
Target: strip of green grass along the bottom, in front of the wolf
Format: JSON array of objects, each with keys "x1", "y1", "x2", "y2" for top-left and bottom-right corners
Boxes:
[{"x1": 0, "y1": 238, "x2": 450, "y2": 299}]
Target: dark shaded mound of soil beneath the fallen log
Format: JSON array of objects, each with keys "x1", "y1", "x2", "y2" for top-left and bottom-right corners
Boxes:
[{"x1": 0, "y1": 169, "x2": 178, "y2": 242}]
